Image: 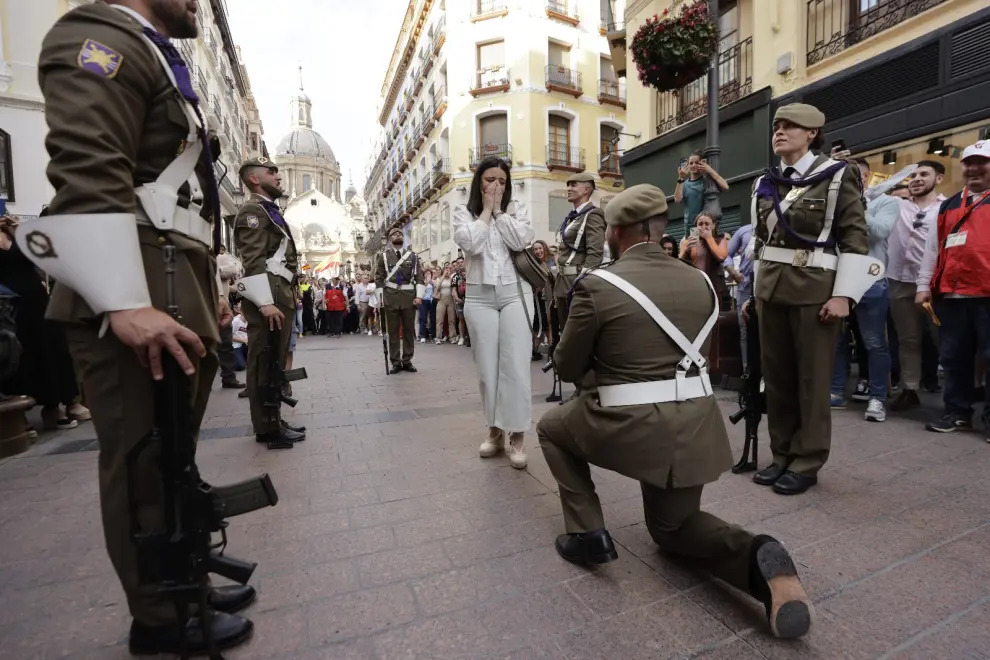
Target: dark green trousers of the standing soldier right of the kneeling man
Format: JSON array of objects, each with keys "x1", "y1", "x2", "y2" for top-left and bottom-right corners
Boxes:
[{"x1": 756, "y1": 300, "x2": 842, "y2": 477}]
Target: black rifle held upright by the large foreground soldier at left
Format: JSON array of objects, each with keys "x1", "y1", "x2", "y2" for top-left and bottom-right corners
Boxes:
[{"x1": 127, "y1": 245, "x2": 278, "y2": 660}]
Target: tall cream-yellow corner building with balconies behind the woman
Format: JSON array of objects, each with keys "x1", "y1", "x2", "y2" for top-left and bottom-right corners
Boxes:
[{"x1": 365, "y1": 0, "x2": 629, "y2": 263}]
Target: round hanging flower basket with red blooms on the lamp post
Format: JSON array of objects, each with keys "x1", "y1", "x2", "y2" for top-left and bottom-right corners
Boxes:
[{"x1": 631, "y1": 0, "x2": 718, "y2": 92}]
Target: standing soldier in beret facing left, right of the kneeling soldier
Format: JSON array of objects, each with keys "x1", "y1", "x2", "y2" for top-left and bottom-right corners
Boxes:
[{"x1": 751, "y1": 103, "x2": 883, "y2": 495}]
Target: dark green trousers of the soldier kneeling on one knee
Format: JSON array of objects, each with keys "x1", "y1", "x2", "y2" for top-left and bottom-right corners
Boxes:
[{"x1": 537, "y1": 415, "x2": 754, "y2": 593}]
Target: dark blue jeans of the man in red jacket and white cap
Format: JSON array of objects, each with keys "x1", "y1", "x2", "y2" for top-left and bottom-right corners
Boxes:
[{"x1": 937, "y1": 298, "x2": 990, "y2": 419}]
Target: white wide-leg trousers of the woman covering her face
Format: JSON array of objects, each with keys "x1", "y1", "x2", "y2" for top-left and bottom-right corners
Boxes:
[{"x1": 464, "y1": 284, "x2": 533, "y2": 433}]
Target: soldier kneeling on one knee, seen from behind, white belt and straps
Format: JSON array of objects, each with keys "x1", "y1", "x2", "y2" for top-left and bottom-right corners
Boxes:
[{"x1": 537, "y1": 184, "x2": 811, "y2": 638}]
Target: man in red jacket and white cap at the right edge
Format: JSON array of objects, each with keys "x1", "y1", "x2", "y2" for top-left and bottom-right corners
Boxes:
[{"x1": 915, "y1": 140, "x2": 990, "y2": 442}]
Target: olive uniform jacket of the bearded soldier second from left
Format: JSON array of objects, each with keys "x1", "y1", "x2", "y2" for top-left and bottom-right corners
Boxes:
[{"x1": 234, "y1": 195, "x2": 299, "y2": 309}]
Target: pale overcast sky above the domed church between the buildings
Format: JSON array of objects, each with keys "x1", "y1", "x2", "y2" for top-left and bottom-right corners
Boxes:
[{"x1": 226, "y1": 0, "x2": 408, "y2": 191}]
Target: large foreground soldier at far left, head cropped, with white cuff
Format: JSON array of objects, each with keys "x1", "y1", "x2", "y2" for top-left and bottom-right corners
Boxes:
[{"x1": 17, "y1": 2, "x2": 255, "y2": 654}]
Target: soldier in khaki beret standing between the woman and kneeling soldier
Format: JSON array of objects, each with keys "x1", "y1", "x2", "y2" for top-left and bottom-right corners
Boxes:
[{"x1": 553, "y1": 172, "x2": 605, "y2": 332}]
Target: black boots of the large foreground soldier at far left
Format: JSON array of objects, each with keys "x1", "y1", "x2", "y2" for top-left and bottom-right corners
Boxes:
[{"x1": 128, "y1": 612, "x2": 254, "y2": 655}]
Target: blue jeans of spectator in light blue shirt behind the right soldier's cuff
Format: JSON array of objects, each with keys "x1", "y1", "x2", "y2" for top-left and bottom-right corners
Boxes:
[{"x1": 832, "y1": 280, "x2": 890, "y2": 401}]
